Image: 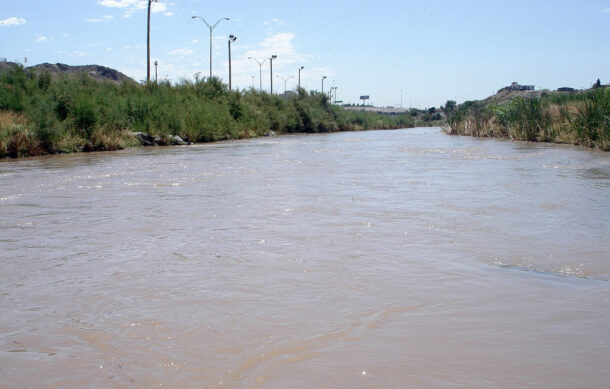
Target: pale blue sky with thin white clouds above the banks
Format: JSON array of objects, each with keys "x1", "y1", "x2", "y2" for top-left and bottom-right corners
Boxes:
[{"x1": 0, "y1": 0, "x2": 610, "y2": 108}]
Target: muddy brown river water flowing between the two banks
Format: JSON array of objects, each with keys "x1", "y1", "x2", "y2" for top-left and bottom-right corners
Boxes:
[{"x1": 0, "y1": 129, "x2": 610, "y2": 388}]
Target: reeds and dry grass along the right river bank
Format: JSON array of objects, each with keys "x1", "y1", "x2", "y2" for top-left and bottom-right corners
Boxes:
[{"x1": 444, "y1": 86, "x2": 610, "y2": 151}]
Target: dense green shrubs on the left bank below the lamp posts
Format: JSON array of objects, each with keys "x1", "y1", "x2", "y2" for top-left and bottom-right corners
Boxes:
[{"x1": 0, "y1": 66, "x2": 414, "y2": 158}]
